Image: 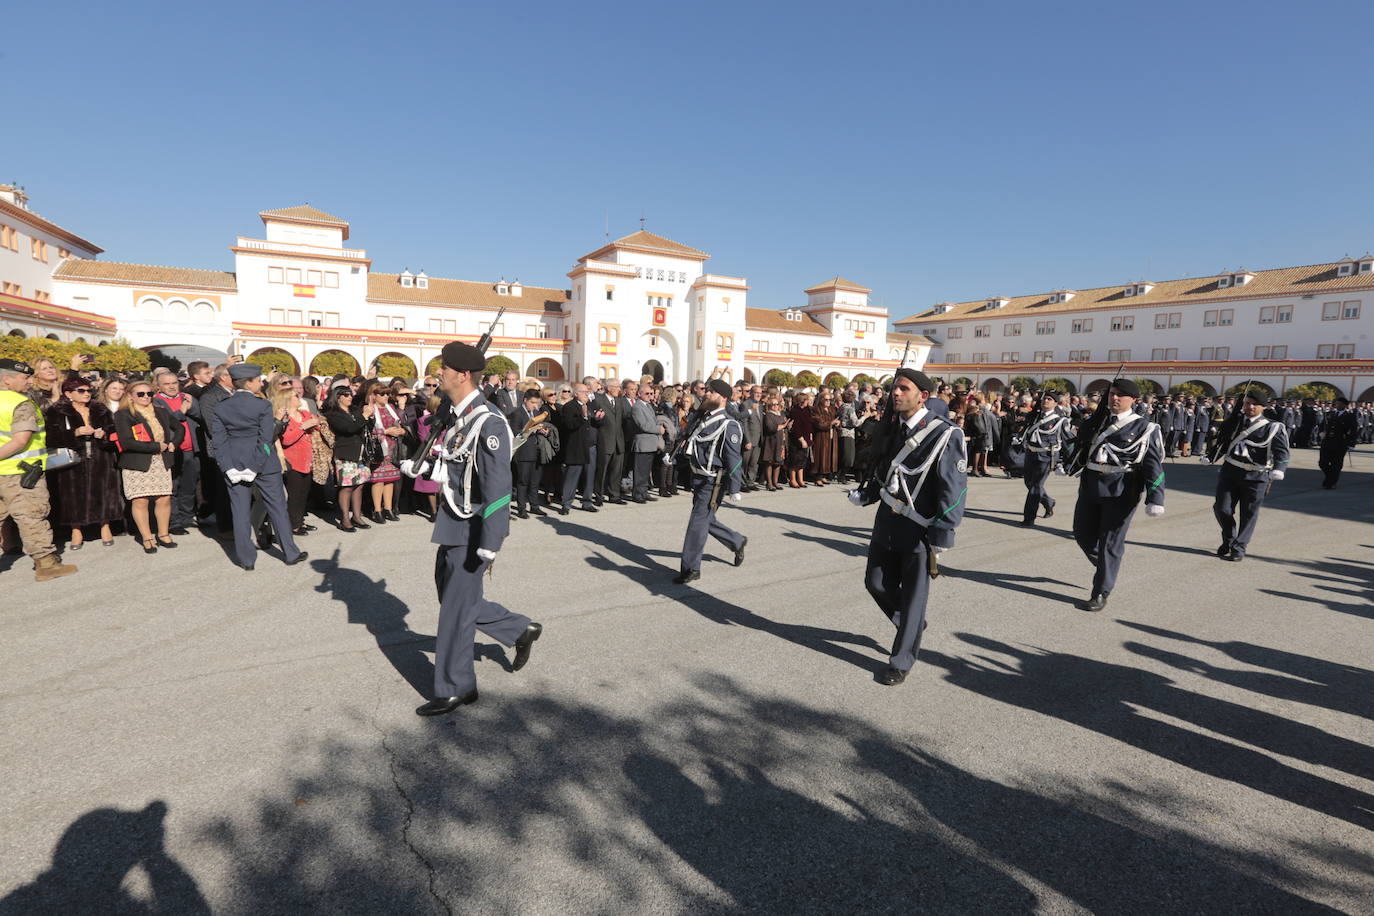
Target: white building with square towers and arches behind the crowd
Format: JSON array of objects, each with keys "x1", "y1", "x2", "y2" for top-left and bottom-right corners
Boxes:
[{"x1": 52, "y1": 206, "x2": 930, "y2": 380}]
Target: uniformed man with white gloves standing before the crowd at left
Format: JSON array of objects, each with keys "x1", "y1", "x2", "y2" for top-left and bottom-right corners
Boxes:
[{"x1": 210, "y1": 363, "x2": 308, "y2": 570}]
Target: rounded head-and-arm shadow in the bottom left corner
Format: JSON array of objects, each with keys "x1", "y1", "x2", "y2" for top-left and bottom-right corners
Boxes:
[{"x1": 0, "y1": 801, "x2": 210, "y2": 916}]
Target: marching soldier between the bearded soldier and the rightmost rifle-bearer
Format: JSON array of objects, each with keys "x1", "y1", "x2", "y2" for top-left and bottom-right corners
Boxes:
[{"x1": 1073, "y1": 379, "x2": 1164, "y2": 611}]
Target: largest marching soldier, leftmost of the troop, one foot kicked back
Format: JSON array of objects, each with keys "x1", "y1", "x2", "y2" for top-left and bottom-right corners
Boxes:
[{"x1": 401, "y1": 341, "x2": 543, "y2": 715}]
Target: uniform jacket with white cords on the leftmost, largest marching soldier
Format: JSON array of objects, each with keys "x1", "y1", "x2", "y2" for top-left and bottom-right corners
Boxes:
[{"x1": 430, "y1": 393, "x2": 511, "y2": 552}]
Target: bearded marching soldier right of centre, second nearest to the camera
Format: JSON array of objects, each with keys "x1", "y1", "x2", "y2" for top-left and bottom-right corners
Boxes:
[{"x1": 848, "y1": 368, "x2": 969, "y2": 687}]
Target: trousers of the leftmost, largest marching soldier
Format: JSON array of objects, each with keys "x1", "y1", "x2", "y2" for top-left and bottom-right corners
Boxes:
[{"x1": 434, "y1": 544, "x2": 529, "y2": 696}]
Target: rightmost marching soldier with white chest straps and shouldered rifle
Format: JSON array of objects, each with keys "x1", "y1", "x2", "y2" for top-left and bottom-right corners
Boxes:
[{"x1": 1202, "y1": 389, "x2": 1289, "y2": 563}]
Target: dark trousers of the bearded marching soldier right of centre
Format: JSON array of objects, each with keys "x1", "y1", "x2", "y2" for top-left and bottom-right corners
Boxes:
[{"x1": 863, "y1": 504, "x2": 930, "y2": 672}]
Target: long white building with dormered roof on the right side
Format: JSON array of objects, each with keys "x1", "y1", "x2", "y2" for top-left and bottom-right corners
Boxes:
[{"x1": 894, "y1": 254, "x2": 1374, "y2": 400}]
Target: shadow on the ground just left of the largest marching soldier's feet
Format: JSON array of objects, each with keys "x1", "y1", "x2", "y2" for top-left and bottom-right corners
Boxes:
[{"x1": 311, "y1": 548, "x2": 445, "y2": 696}]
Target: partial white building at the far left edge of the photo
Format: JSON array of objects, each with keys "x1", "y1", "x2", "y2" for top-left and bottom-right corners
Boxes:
[{"x1": 0, "y1": 184, "x2": 115, "y2": 343}]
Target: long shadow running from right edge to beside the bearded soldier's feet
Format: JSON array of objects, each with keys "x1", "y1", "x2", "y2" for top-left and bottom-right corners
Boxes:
[{"x1": 922, "y1": 633, "x2": 1374, "y2": 829}]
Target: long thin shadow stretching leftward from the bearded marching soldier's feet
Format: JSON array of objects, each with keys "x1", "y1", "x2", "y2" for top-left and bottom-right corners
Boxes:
[{"x1": 551, "y1": 519, "x2": 886, "y2": 672}]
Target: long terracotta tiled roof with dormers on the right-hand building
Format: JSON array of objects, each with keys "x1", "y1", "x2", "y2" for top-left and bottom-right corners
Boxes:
[{"x1": 894, "y1": 261, "x2": 1374, "y2": 324}]
